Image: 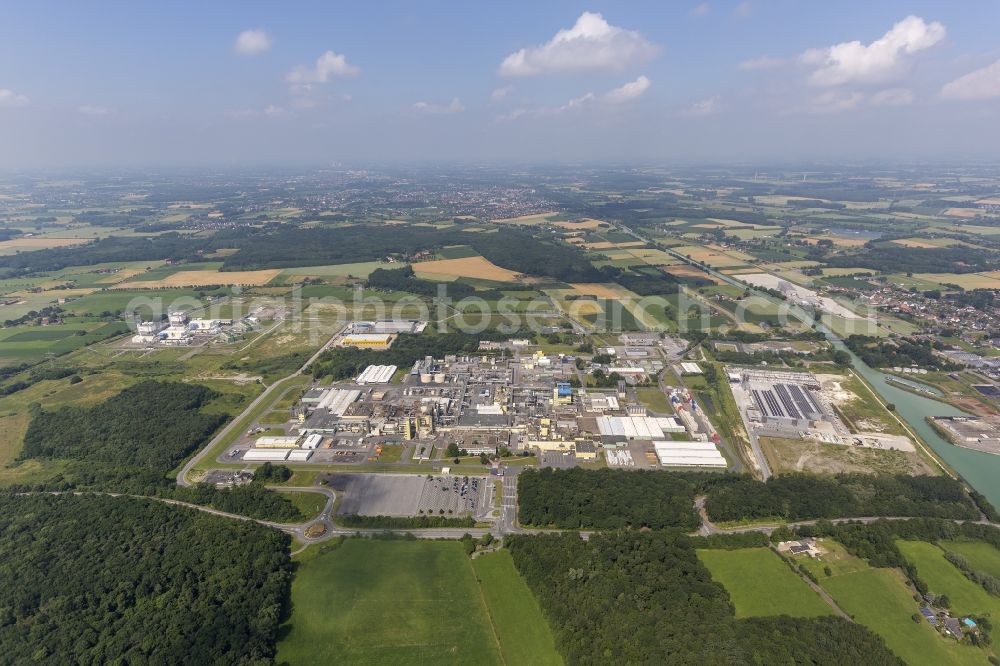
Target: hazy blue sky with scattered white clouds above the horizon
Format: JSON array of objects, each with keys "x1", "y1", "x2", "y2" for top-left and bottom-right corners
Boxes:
[{"x1": 0, "y1": 0, "x2": 1000, "y2": 168}]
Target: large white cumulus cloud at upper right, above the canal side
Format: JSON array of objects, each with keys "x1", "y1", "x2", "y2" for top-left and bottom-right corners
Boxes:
[{"x1": 800, "y1": 15, "x2": 945, "y2": 86}]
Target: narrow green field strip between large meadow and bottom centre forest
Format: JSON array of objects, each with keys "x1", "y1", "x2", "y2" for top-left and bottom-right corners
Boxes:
[{"x1": 472, "y1": 550, "x2": 563, "y2": 666}]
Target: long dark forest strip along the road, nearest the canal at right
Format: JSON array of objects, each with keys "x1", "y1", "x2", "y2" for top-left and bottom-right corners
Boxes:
[{"x1": 705, "y1": 473, "x2": 979, "y2": 521}]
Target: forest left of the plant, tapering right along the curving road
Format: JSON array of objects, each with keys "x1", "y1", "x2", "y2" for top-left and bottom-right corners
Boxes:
[{"x1": 21, "y1": 381, "x2": 303, "y2": 522}]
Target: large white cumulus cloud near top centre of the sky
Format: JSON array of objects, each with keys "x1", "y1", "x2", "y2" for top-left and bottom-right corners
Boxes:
[{"x1": 500, "y1": 12, "x2": 658, "y2": 76}]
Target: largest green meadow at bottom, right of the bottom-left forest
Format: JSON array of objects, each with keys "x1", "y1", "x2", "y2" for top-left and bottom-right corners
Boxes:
[{"x1": 277, "y1": 539, "x2": 503, "y2": 666}]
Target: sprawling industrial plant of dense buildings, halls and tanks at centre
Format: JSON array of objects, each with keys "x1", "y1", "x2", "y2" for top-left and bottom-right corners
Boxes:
[{"x1": 224, "y1": 321, "x2": 729, "y2": 469}]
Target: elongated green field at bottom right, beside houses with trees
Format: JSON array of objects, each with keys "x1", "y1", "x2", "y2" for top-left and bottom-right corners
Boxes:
[{"x1": 799, "y1": 539, "x2": 986, "y2": 665}]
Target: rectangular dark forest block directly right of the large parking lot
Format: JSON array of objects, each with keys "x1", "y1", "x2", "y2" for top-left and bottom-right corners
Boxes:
[{"x1": 517, "y1": 467, "x2": 700, "y2": 530}]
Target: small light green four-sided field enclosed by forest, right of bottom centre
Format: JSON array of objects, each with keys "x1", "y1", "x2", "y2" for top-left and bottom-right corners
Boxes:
[{"x1": 698, "y1": 548, "x2": 833, "y2": 617}]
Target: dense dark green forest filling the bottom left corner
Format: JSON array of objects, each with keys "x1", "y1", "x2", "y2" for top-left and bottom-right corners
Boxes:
[{"x1": 0, "y1": 494, "x2": 290, "y2": 665}]
